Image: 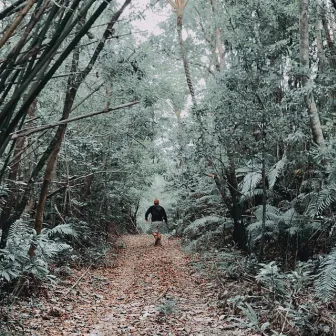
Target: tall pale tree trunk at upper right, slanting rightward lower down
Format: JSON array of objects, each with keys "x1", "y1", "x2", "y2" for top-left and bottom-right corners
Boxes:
[{"x1": 300, "y1": 0, "x2": 324, "y2": 146}]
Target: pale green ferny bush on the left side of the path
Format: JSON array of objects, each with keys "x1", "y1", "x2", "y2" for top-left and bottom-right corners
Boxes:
[{"x1": 0, "y1": 219, "x2": 108, "y2": 291}]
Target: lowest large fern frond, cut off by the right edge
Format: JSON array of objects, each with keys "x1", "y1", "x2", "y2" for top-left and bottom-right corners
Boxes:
[{"x1": 315, "y1": 249, "x2": 336, "y2": 302}]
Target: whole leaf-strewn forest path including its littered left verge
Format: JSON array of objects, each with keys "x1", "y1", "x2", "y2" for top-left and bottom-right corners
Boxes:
[{"x1": 21, "y1": 235, "x2": 244, "y2": 336}]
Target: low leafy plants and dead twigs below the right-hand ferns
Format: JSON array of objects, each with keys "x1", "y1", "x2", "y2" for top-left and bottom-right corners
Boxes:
[{"x1": 191, "y1": 244, "x2": 336, "y2": 336}]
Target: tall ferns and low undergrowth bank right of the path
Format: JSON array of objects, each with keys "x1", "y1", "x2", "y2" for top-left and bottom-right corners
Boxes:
[{"x1": 175, "y1": 145, "x2": 336, "y2": 336}]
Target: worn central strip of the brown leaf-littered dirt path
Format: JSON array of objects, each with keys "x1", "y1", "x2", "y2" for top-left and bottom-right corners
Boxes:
[{"x1": 86, "y1": 235, "x2": 243, "y2": 336}]
